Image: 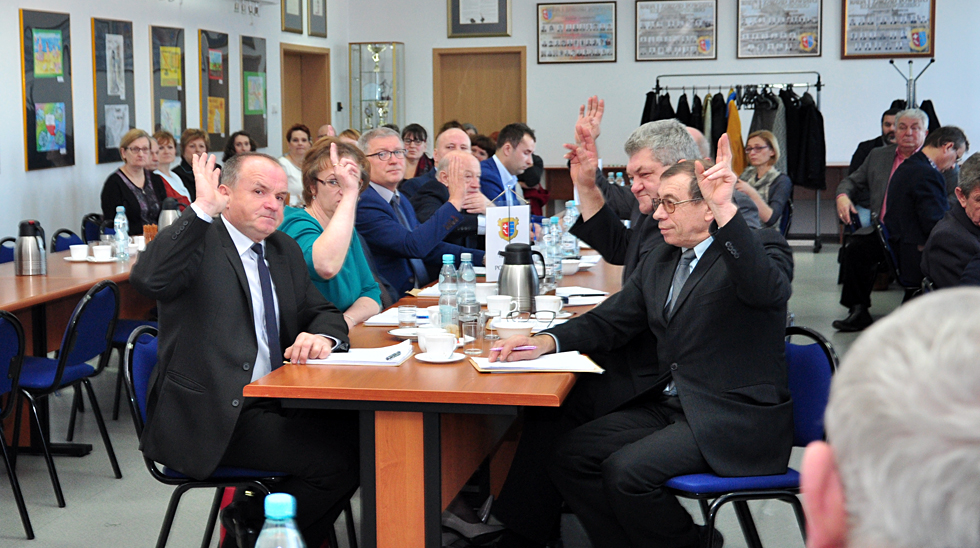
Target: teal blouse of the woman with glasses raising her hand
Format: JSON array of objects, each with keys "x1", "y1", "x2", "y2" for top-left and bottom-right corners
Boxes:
[{"x1": 279, "y1": 207, "x2": 381, "y2": 311}]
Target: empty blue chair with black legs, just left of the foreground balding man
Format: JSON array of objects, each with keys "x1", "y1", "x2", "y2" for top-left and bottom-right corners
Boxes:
[{"x1": 14, "y1": 280, "x2": 122, "y2": 507}]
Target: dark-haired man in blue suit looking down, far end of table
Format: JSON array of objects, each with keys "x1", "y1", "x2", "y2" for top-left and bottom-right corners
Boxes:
[{"x1": 480, "y1": 123, "x2": 535, "y2": 203}]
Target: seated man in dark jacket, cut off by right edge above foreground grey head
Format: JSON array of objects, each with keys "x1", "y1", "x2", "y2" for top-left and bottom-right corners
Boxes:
[{"x1": 922, "y1": 154, "x2": 980, "y2": 289}]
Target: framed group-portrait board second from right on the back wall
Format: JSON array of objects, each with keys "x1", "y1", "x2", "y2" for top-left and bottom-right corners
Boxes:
[{"x1": 738, "y1": 0, "x2": 823, "y2": 59}]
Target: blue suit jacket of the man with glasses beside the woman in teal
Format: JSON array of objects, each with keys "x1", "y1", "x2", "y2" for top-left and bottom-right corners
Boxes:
[{"x1": 355, "y1": 186, "x2": 483, "y2": 295}]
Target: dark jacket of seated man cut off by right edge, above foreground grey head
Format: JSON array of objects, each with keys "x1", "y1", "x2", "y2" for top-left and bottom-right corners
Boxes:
[{"x1": 922, "y1": 200, "x2": 980, "y2": 288}]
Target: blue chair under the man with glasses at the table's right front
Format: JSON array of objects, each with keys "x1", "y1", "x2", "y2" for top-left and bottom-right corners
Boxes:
[{"x1": 666, "y1": 326, "x2": 838, "y2": 548}]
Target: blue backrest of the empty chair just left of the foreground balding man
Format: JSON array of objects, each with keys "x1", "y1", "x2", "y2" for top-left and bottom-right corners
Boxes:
[{"x1": 51, "y1": 280, "x2": 119, "y2": 390}]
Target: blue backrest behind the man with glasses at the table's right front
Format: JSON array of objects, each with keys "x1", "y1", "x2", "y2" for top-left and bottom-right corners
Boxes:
[{"x1": 786, "y1": 325, "x2": 839, "y2": 447}]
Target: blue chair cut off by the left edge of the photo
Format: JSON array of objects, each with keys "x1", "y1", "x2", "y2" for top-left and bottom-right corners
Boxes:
[{"x1": 0, "y1": 310, "x2": 34, "y2": 540}]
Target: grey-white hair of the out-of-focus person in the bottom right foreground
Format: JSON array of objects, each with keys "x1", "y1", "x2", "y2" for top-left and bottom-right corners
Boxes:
[{"x1": 826, "y1": 288, "x2": 980, "y2": 548}]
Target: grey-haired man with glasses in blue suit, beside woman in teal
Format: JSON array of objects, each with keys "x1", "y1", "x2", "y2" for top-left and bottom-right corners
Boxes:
[{"x1": 356, "y1": 127, "x2": 483, "y2": 295}]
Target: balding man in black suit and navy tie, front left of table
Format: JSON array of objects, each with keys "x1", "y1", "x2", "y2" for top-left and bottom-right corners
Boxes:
[{"x1": 130, "y1": 153, "x2": 358, "y2": 546}]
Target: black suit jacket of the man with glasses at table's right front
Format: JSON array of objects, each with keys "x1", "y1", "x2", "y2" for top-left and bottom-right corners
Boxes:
[{"x1": 549, "y1": 215, "x2": 793, "y2": 476}]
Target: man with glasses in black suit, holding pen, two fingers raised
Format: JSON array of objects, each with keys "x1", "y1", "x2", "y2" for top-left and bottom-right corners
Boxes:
[{"x1": 491, "y1": 137, "x2": 793, "y2": 548}]
